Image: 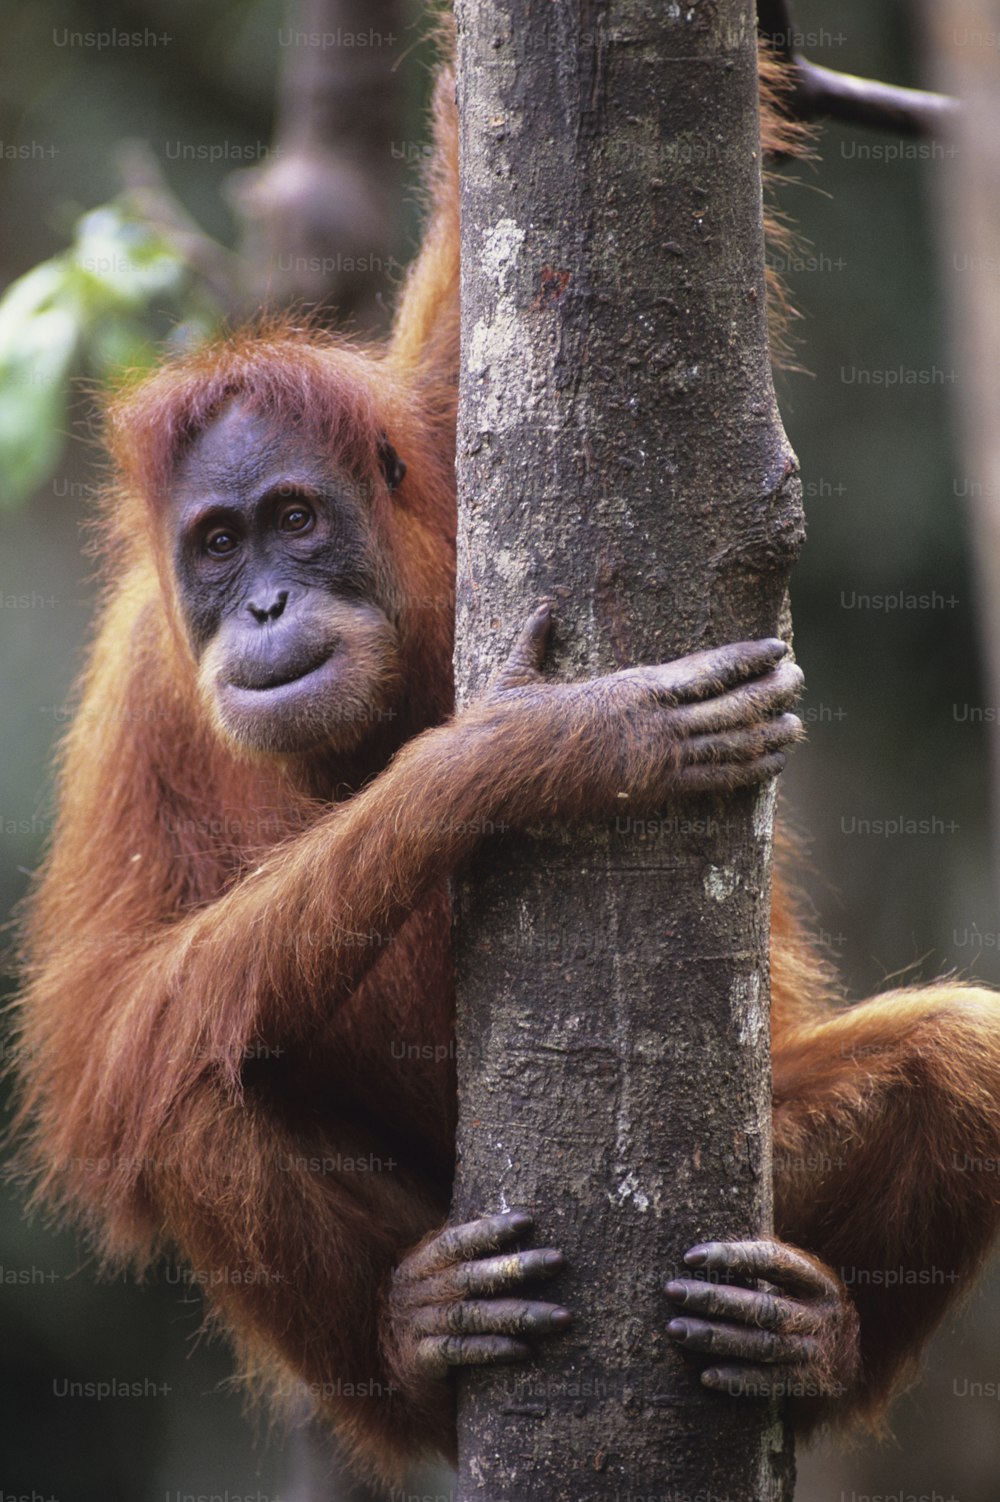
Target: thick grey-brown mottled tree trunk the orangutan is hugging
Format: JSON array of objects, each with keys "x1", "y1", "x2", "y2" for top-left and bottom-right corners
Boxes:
[{"x1": 455, "y1": 0, "x2": 800, "y2": 1502}]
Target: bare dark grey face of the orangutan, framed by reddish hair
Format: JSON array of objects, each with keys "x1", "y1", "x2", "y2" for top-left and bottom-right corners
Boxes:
[{"x1": 173, "y1": 403, "x2": 399, "y2": 753}]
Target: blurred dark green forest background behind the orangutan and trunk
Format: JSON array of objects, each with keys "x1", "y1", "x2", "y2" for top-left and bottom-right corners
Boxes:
[{"x1": 0, "y1": 0, "x2": 1000, "y2": 1502}]
